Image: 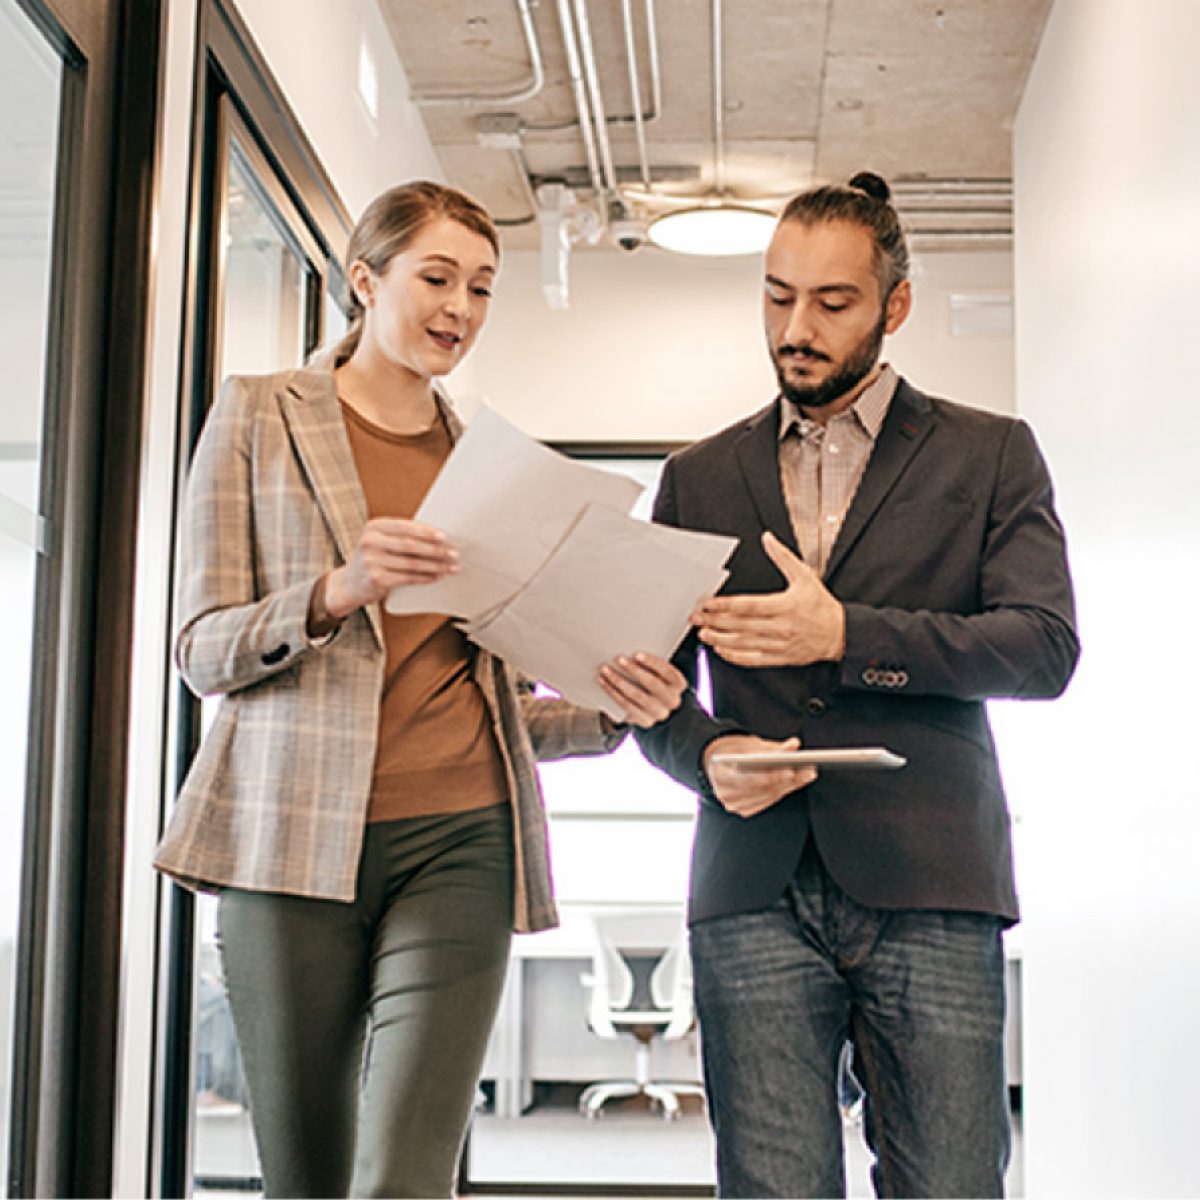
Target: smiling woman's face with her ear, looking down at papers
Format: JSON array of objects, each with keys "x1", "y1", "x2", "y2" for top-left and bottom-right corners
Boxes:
[{"x1": 350, "y1": 217, "x2": 497, "y2": 379}]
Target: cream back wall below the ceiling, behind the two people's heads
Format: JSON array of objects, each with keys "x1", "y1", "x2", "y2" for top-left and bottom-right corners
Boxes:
[{"x1": 450, "y1": 241, "x2": 1014, "y2": 440}]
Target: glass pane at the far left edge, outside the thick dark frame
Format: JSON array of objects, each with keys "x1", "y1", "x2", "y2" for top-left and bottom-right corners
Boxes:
[{"x1": 0, "y1": 0, "x2": 62, "y2": 1178}]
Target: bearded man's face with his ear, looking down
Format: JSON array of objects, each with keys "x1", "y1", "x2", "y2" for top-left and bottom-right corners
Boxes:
[{"x1": 763, "y1": 221, "x2": 911, "y2": 421}]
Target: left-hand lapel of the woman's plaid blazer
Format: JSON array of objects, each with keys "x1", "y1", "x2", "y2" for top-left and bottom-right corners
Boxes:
[{"x1": 280, "y1": 367, "x2": 383, "y2": 644}]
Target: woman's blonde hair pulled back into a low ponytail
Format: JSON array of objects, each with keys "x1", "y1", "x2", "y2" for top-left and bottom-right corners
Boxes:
[{"x1": 335, "y1": 179, "x2": 500, "y2": 362}]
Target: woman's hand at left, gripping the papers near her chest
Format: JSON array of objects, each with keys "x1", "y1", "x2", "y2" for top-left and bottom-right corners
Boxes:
[{"x1": 325, "y1": 517, "x2": 458, "y2": 620}]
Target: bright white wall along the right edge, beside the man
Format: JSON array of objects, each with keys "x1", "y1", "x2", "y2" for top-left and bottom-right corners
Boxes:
[{"x1": 1014, "y1": 0, "x2": 1200, "y2": 1200}]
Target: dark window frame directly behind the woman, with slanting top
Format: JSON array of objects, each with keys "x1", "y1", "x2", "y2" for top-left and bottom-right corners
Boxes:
[{"x1": 150, "y1": 0, "x2": 352, "y2": 1200}]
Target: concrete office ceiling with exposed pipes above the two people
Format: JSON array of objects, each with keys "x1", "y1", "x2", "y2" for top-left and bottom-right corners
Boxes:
[{"x1": 379, "y1": 0, "x2": 1052, "y2": 248}]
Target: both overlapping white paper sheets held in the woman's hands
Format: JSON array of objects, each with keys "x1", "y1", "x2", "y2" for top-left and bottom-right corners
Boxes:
[{"x1": 386, "y1": 408, "x2": 737, "y2": 719}]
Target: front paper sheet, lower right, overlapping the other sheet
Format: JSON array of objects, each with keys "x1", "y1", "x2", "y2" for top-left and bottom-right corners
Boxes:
[{"x1": 464, "y1": 505, "x2": 737, "y2": 720}]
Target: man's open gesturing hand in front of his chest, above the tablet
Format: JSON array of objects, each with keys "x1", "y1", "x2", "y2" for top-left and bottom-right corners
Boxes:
[{"x1": 691, "y1": 533, "x2": 846, "y2": 667}]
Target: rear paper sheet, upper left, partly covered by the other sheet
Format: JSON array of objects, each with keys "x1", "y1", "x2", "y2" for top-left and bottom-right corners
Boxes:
[{"x1": 385, "y1": 407, "x2": 642, "y2": 619}]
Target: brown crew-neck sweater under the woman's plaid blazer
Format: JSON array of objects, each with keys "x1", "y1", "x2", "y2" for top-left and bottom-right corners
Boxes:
[{"x1": 342, "y1": 403, "x2": 509, "y2": 821}]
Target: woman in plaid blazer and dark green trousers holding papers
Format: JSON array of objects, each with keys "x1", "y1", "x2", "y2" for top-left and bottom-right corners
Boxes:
[{"x1": 157, "y1": 184, "x2": 683, "y2": 1200}]
